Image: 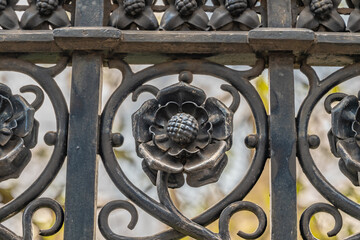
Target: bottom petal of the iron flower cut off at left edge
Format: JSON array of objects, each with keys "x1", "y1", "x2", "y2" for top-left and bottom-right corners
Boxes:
[{"x1": 0, "y1": 137, "x2": 31, "y2": 182}]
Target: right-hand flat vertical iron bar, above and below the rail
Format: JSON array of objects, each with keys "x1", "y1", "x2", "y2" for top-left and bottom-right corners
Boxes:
[{"x1": 267, "y1": 0, "x2": 297, "y2": 240}]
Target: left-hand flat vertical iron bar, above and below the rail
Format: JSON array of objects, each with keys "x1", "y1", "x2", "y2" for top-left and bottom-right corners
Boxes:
[{"x1": 64, "y1": 0, "x2": 104, "y2": 240}]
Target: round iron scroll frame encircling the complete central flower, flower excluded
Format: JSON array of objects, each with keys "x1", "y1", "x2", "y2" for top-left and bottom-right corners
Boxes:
[{"x1": 99, "y1": 59, "x2": 268, "y2": 239}]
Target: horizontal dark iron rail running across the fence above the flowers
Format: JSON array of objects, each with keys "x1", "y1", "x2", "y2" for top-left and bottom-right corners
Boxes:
[{"x1": 0, "y1": 27, "x2": 360, "y2": 66}]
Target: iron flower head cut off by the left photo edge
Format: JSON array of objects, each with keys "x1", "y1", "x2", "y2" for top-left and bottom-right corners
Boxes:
[{"x1": 0, "y1": 84, "x2": 39, "y2": 181}]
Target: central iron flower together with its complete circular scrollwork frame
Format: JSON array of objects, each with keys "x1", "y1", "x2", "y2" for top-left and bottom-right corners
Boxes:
[{"x1": 99, "y1": 59, "x2": 268, "y2": 240}]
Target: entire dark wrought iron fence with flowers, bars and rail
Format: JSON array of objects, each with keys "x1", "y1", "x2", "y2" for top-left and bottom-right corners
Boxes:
[{"x1": 0, "y1": 0, "x2": 360, "y2": 240}]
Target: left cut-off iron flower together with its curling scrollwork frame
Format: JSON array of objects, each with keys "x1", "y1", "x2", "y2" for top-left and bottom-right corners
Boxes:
[{"x1": 0, "y1": 58, "x2": 68, "y2": 240}]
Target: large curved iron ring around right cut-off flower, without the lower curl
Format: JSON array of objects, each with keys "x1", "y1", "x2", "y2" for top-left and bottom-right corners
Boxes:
[{"x1": 297, "y1": 63, "x2": 360, "y2": 239}]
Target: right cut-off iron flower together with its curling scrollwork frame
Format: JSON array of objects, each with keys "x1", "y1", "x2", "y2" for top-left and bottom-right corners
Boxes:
[{"x1": 297, "y1": 63, "x2": 360, "y2": 240}]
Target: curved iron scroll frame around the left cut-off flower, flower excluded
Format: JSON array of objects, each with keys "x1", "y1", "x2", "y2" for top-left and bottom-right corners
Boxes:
[{"x1": 0, "y1": 58, "x2": 68, "y2": 239}]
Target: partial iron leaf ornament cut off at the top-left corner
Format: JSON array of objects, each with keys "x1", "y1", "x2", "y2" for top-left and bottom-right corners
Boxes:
[{"x1": 0, "y1": 0, "x2": 20, "y2": 30}]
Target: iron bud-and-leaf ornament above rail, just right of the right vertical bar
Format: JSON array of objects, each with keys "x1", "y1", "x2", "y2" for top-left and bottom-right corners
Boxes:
[{"x1": 296, "y1": 0, "x2": 345, "y2": 32}]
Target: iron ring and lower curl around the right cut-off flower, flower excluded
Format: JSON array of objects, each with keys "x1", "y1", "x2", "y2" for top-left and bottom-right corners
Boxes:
[{"x1": 297, "y1": 64, "x2": 360, "y2": 239}]
